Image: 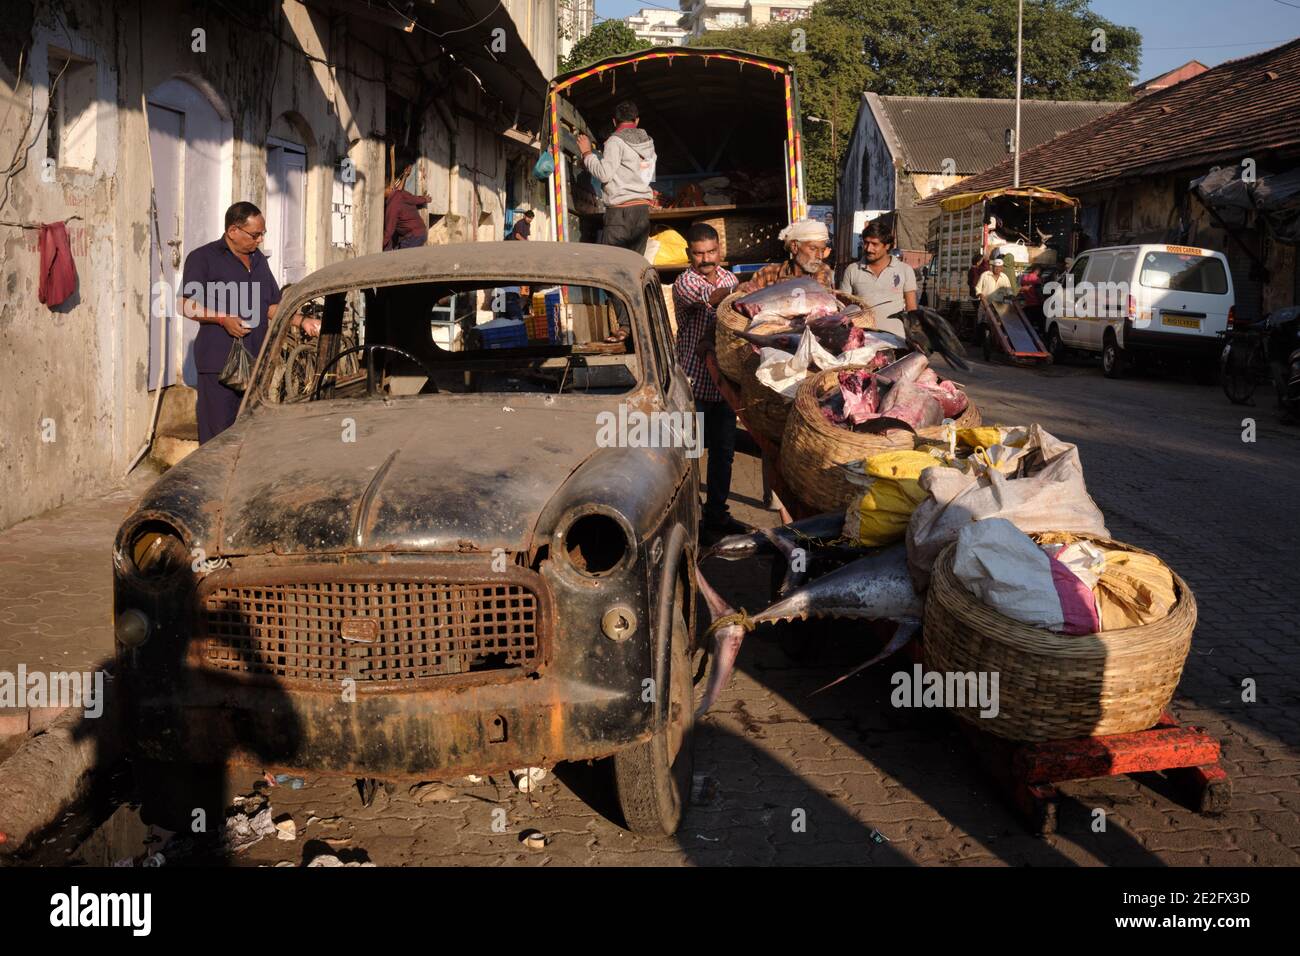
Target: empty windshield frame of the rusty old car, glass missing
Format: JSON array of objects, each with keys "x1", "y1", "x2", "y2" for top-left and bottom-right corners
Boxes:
[{"x1": 239, "y1": 269, "x2": 657, "y2": 418}]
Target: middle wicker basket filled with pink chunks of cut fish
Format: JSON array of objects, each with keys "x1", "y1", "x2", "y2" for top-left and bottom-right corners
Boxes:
[{"x1": 781, "y1": 365, "x2": 980, "y2": 514}]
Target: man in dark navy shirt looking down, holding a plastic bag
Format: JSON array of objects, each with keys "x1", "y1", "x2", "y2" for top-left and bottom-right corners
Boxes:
[{"x1": 181, "y1": 203, "x2": 280, "y2": 445}]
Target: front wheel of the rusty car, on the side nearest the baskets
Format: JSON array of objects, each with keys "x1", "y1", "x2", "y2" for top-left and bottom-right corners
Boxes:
[{"x1": 614, "y1": 581, "x2": 696, "y2": 836}]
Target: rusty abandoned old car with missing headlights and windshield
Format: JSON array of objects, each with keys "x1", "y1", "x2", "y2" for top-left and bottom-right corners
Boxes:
[{"x1": 113, "y1": 242, "x2": 699, "y2": 832}]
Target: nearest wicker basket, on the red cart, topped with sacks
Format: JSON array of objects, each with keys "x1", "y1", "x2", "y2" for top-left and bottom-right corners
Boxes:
[{"x1": 922, "y1": 535, "x2": 1196, "y2": 741}]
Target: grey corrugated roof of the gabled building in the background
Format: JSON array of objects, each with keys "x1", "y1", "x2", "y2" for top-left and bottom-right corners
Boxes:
[{"x1": 868, "y1": 94, "x2": 1125, "y2": 176}]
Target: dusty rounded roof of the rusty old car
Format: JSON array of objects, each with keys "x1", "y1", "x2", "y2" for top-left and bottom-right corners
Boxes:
[{"x1": 279, "y1": 241, "x2": 651, "y2": 304}]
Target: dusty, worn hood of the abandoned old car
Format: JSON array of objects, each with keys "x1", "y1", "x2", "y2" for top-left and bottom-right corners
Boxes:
[{"x1": 218, "y1": 395, "x2": 601, "y2": 554}]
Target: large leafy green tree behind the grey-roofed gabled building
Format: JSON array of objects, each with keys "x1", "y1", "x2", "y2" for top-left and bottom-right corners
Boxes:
[{"x1": 692, "y1": 0, "x2": 1141, "y2": 202}]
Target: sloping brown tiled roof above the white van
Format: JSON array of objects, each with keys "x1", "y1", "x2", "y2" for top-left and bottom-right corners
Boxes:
[{"x1": 922, "y1": 39, "x2": 1300, "y2": 206}]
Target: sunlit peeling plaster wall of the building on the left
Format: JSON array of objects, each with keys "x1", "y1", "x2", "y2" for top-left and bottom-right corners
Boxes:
[{"x1": 0, "y1": 0, "x2": 543, "y2": 528}]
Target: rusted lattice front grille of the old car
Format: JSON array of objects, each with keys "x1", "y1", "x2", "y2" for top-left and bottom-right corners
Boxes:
[{"x1": 202, "y1": 580, "x2": 541, "y2": 683}]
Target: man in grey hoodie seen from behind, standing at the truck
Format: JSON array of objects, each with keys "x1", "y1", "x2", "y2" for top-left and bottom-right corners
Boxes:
[{"x1": 577, "y1": 100, "x2": 655, "y2": 254}]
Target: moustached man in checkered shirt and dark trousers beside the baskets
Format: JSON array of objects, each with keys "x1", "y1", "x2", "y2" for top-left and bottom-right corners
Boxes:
[{"x1": 672, "y1": 222, "x2": 750, "y2": 536}]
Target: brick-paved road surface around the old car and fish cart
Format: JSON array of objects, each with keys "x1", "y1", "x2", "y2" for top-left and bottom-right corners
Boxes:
[{"x1": 0, "y1": 363, "x2": 1300, "y2": 866}]
